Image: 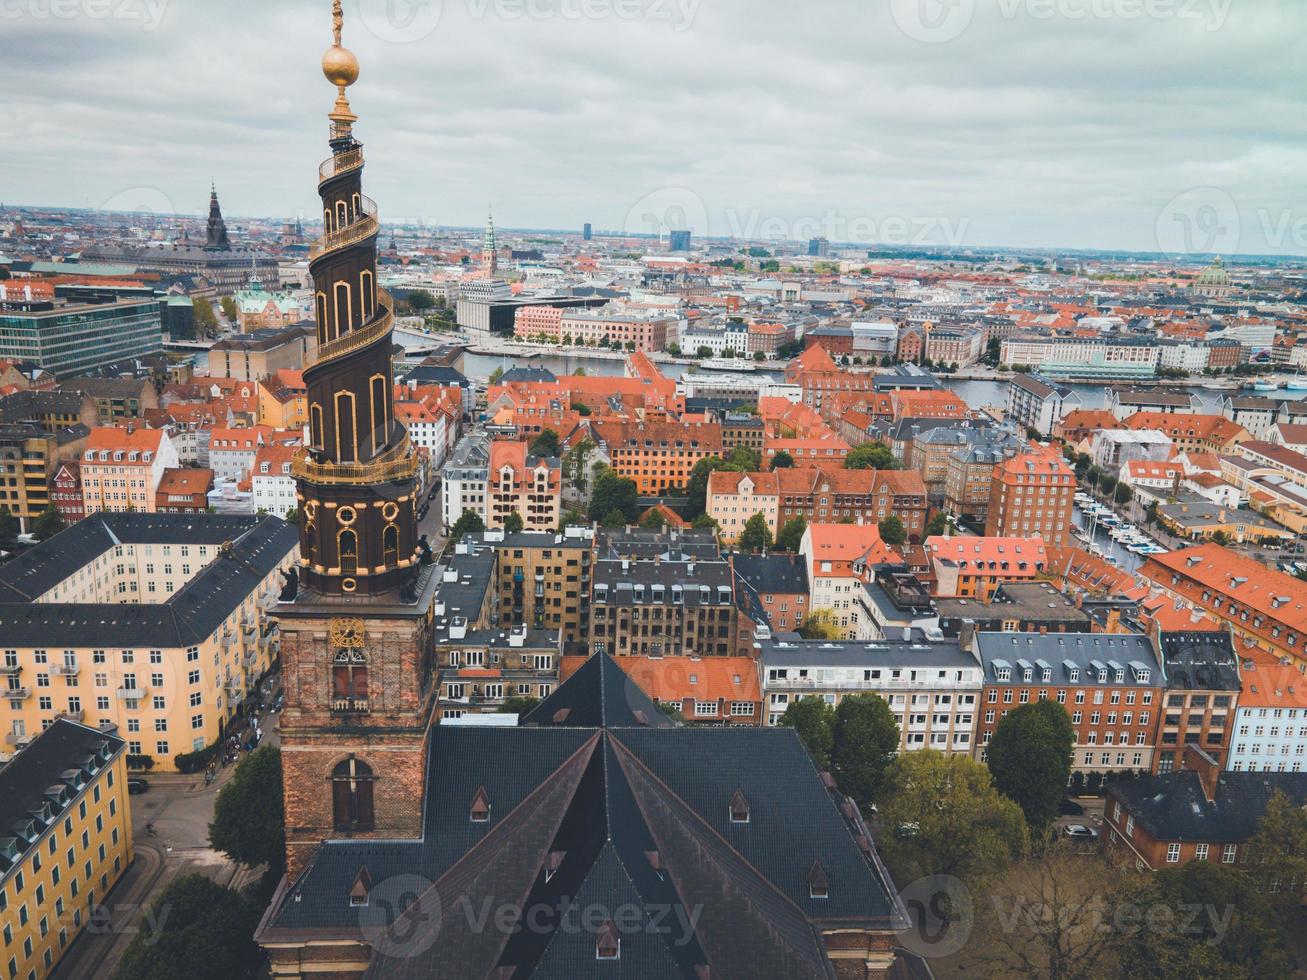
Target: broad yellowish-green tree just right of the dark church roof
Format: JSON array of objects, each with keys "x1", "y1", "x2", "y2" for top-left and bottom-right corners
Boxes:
[{"x1": 878, "y1": 749, "x2": 1030, "y2": 883}]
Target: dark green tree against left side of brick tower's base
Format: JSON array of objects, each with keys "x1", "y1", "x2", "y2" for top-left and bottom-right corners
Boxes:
[{"x1": 209, "y1": 745, "x2": 286, "y2": 868}]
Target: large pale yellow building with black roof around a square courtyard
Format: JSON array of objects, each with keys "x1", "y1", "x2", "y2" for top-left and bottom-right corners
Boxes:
[{"x1": 0, "y1": 514, "x2": 299, "y2": 771}]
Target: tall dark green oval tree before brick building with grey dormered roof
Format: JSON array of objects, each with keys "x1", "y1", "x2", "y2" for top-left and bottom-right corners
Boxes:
[{"x1": 987, "y1": 700, "x2": 1076, "y2": 832}]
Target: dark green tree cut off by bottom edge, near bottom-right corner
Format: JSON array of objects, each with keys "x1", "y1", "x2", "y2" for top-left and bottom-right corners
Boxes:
[{"x1": 1120, "y1": 861, "x2": 1298, "y2": 980}]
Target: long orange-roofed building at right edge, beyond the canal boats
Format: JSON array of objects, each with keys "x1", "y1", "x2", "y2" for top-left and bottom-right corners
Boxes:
[{"x1": 1140, "y1": 545, "x2": 1307, "y2": 672}]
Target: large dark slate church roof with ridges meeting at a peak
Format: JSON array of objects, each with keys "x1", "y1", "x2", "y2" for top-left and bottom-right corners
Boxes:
[{"x1": 260, "y1": 655, "x2": 904, "y2": 980}]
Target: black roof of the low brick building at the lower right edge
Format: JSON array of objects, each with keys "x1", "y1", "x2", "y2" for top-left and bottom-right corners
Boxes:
[{"x1": 1107, "y1": 770, "x2": 1307, "y2": 844}]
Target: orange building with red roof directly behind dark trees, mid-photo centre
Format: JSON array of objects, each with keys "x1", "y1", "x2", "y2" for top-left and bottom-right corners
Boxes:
[{"x1": 589, "y1": 419, "x2": 723, "y2": 497}]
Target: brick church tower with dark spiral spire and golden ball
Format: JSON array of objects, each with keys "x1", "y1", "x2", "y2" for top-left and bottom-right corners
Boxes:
[{"x1": 274, "y1": 0, "x2": 438, "y2": 881}]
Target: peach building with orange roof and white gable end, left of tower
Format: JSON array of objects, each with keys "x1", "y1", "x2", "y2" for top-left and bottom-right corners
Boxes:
[{"x1": 81, "y1": 425, "x2": 182, "y2": 514}]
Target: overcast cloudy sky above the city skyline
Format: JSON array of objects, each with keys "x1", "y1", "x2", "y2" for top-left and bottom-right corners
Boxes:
[{"x1": 10, "y1": 0, "x2": 1307, "y2": 255}]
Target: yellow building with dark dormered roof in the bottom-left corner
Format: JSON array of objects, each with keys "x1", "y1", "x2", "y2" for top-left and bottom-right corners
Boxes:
[{"x1": 0, "y1": 719, "x2": 132, "y2": 980}]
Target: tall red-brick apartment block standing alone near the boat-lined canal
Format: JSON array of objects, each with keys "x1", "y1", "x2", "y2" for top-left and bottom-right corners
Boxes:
[{"x1": 984, "y1": 447, "x2": 1076, "y2": 547}]
